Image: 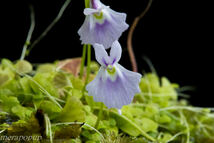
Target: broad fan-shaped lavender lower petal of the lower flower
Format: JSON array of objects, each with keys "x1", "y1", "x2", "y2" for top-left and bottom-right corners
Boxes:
[{"x1": 86, "y1": 64, "x2": 141, "y2": 109}]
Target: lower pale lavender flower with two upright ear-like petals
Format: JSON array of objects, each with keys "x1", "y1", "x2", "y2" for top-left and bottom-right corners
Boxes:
[{"x1": 86, "y1": 41, "x2": 141, "y2": 109}]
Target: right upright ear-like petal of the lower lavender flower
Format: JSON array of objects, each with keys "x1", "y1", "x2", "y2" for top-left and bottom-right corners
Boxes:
[{"x1": 110, "y1": 41, "x2": 122, "y2": 65}]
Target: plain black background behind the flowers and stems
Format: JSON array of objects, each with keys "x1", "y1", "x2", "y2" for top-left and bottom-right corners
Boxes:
[{"x1": 0, "y1": 0, "x2": 214, "y2": 106}]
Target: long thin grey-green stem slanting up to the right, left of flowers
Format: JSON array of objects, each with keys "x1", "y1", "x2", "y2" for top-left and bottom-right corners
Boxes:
[{"x1": 28, "y1": 0, "x2": 71, "y2": 55}]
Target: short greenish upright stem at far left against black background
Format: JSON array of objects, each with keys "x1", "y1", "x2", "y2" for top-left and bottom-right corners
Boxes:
[{"x1": 20, "y1": 5, "x2": 35, "y2": 60}]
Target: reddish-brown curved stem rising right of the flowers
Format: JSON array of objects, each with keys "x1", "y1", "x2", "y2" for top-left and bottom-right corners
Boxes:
[{"x1": 127, "y1": 0, "x2": 152, "y2": 72}]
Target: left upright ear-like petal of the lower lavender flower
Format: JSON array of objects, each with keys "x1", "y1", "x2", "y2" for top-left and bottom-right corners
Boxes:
[{"x1": 93, "y1": 43, "x2": 109, "y2": 66}]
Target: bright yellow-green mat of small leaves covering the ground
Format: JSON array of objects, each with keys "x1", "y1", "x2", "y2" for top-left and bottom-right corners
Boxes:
[{"x1": 0, "y1": 59, "x2": 214, "y2": 143}]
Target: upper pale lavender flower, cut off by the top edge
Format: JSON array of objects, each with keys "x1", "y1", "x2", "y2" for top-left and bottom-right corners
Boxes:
[{"x1": 78, "y1": 0, "x2": 129, "y2": 49}]
